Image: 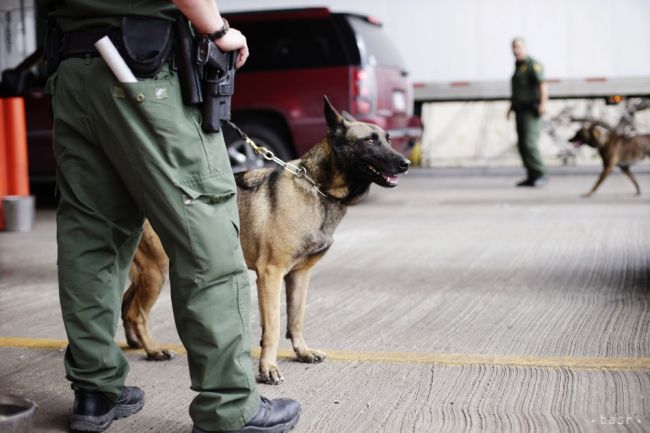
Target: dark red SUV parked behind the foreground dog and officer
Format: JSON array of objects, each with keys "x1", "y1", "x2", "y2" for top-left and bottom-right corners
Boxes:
[{"x1": 224, "y1": 8, "x2": 422, "y2": 170}]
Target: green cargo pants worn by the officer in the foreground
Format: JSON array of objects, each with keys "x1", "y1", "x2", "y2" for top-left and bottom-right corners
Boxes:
[{"x1": 47, "y1": 59, "x2": 260, "y2": 431}]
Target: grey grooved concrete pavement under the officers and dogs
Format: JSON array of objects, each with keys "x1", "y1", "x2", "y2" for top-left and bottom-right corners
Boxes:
[{"x1": 0, "y1": 164, "x2": 650, "y2": 433}]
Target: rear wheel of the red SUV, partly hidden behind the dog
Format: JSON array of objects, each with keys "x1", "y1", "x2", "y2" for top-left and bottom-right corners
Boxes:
[{"x1": 224, "y1": 123, "x2": 291, "y2": 173}]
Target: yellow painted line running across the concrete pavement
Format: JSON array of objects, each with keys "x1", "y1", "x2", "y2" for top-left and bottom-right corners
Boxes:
[{"x1": 0, "y1": 337, "x2": 650, "y2": 370}]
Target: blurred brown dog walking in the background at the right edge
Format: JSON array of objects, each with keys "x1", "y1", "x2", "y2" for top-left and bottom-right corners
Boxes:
[{"x1": 569, "y1": 123, "x2": 650, "y2": 197}]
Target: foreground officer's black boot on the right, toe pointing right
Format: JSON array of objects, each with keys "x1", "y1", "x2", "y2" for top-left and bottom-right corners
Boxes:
[{"x1": 192, "y1": 397, "x2": 300, "y2": 433}]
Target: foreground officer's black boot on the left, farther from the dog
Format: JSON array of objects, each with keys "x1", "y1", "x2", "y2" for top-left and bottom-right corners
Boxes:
[{"x1": 70, "y1": 386, "x2": 144, "y2": 432}]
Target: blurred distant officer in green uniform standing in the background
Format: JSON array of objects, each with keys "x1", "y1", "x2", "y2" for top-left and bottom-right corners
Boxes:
[{"x1": 508, "y1": 38, "x2": 548, "y2": 187}]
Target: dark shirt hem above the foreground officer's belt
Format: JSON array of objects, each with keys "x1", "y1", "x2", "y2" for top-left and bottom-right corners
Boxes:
[{"x1": 37, "y1": 0, "x2": 180, "y2": 32}]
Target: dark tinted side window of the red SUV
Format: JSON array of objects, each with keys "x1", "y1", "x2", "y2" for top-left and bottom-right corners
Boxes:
[{"x1": 232, "y1": 18, "x2": 347, "y2": 72}]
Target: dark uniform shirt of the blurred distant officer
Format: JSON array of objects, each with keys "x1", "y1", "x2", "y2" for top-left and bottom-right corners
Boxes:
[{"x1": 511, "y1": 57, "x2": 544, "y2": 111}]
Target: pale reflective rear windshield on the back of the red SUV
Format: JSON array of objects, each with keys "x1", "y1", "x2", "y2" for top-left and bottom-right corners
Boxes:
[{"x1": 348, "y1": 16, "x2": 406, "y2": 70}]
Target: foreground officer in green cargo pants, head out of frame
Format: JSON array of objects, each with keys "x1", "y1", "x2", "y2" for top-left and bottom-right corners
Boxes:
[{"x1": 39, "y1": 0, "x2": 300, "y2": 433}]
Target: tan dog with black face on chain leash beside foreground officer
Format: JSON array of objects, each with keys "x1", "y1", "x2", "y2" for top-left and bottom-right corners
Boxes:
[{"x1": 122, "y1": 97, "x2": 410, "y2": 384}]
